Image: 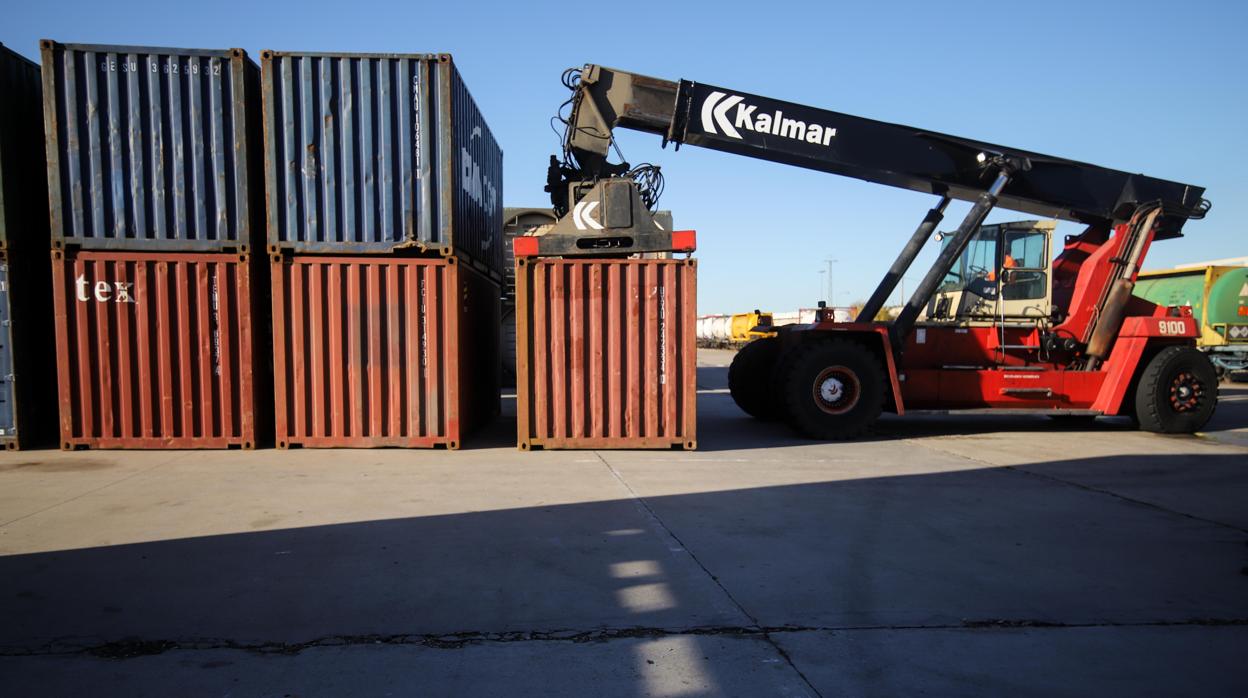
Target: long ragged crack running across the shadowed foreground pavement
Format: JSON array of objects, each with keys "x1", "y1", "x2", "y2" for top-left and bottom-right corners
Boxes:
[{"x1": 0, "y1": 618, "x2": 1248, "y2": 659}]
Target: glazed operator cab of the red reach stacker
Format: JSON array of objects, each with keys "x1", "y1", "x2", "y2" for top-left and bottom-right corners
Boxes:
[{"x1": 920, "y1": 221, "x2": 1057, "y2": 325}]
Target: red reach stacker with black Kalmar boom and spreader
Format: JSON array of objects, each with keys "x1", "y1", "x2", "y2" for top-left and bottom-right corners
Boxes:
[{"x1": 543, "y1": 65, "x2": 1217, "y2": 438}]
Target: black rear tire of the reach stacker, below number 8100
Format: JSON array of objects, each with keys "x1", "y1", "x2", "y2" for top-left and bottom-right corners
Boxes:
[{"x1": 1136, "y1": 347, "x2": 1218, "y2": 433}]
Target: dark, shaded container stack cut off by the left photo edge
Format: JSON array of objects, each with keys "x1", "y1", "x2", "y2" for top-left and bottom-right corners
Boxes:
[{"x1": 0, "y1": 45, "x2": 56, "y2": 448}]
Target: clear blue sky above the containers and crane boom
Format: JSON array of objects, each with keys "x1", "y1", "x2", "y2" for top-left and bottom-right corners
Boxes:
[{"x1": 0, "y1": 0, "x2": 1248, "y2": 313}]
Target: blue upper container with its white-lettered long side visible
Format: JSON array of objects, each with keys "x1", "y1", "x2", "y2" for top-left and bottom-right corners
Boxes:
[{"x1": 261, "y1": 51, "x2": 503, "y2": 278}]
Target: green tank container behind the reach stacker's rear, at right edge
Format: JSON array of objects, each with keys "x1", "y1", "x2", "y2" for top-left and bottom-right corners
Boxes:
[{"x1": 1136, "y1": 265, "x2": 1248, "y2": 371}]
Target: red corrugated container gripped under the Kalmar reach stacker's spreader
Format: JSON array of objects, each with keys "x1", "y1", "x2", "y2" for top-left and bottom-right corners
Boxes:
[{"x1": 515, "y1": 257, "x2": 698, "y2": 450}]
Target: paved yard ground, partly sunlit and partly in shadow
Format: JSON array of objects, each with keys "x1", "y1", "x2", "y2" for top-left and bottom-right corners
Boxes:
[{"x1": 0, "y1": 351, "x2": 1248, "y2": 697}]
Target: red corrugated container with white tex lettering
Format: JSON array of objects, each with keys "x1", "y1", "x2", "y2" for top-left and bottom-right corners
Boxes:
[{"x1": 52, "y1": 250, "x2": 265, "y2": 450}]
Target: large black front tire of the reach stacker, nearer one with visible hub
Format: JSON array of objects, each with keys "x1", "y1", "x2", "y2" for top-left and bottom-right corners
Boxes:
[{"x1": 776, "y1": 340, "x2": 889, "y2": 441}]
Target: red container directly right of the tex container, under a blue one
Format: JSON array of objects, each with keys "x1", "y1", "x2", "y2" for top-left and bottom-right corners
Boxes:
[{"x1": 271, "y1": 255, "x2": 500, "y2": 448}]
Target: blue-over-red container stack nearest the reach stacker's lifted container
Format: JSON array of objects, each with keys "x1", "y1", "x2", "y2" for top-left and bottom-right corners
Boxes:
[{"x1": 261, "y1": 51, "x2": 503, "y2": 448}]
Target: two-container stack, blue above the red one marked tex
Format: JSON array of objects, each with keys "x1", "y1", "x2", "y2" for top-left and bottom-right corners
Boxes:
[{"x1": 41, "y1": 40, "x2": 271, "y2": 448}]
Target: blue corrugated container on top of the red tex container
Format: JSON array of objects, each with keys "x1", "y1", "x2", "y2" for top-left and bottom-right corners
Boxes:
[{"x1": 40, "y1": 40, "x2": 263, "y2": 252}]
